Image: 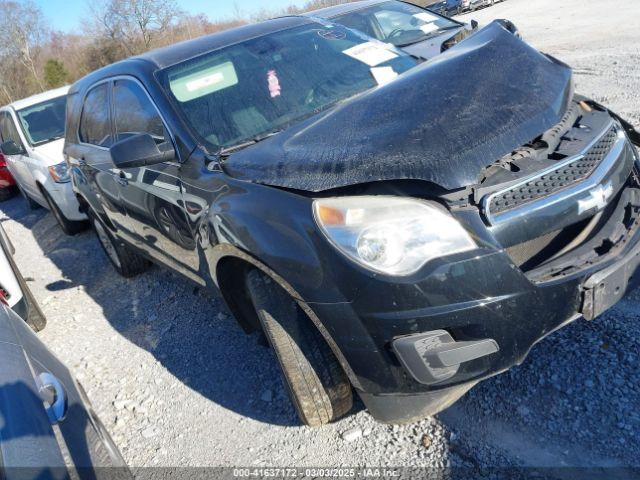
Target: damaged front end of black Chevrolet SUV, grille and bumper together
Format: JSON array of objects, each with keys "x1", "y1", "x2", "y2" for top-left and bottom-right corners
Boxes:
[{"x1": 353, "y1": 97, "x2": 640, "y2": 421}]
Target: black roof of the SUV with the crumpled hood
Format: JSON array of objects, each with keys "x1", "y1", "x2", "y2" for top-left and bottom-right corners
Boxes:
[{"x1": 70, "y1": 16, "x2": 313, "y2": 93}]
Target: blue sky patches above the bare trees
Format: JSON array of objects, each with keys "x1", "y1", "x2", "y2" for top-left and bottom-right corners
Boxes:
[{"x1": 35, "y1": 0, "x2": 305, "y2": 32}]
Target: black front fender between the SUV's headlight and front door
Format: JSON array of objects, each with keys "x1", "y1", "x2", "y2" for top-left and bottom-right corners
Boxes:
[{"x1": 197, "y1": 181, "x2": 364, "y2": 303}]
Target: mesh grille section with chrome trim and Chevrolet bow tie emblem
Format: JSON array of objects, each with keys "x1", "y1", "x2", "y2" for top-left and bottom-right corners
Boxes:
[{"x1": 467, "y1": 97, "x2": 640, "y2": 319}]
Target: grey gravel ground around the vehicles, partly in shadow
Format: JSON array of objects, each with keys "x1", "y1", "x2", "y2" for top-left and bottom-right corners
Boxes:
[{"x1": 0, "y1": 0, "x2": 640, "y2": 468}]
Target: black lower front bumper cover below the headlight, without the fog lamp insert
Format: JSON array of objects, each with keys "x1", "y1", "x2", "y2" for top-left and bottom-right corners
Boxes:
[{"x1": 320, "y1": 220, "x2": 640, "y2": 423}]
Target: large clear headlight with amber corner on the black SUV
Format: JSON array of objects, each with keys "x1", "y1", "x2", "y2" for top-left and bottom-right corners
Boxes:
[{"x1": 313, "y1": 196, "x2": 476, "y2": 275}]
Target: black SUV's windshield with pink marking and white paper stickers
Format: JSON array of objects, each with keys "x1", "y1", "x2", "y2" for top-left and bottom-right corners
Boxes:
[{"x1": 160, "y1": 23, "x2": 417, "y2": 151}]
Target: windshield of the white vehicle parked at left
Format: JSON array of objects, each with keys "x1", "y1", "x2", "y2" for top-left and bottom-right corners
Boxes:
[{"x1": 16, "y1": 95, "x2": 67, "y2": 146}]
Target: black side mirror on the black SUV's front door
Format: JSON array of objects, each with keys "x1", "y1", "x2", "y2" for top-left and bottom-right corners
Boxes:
[{"x1": 109, "y1": 133, "x2": 176, "y2": 168}]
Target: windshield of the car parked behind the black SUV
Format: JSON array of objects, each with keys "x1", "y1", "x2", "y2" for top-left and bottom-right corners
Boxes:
[{"x1": 331, "y1": 2, "x2": 461, "y2": 47}]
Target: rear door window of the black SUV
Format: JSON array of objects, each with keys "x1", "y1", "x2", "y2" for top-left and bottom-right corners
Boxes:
[{"x1": 80, "y1": 83, "x2": 113, "y2": 148}]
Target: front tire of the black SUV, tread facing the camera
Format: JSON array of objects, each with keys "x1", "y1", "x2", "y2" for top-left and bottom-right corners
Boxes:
[{"x1": 246, "y1": 270, "x2": 353, "y2": 427}]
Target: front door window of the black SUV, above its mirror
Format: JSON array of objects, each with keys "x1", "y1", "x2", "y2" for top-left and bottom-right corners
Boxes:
[{"x1": 113, "y1": 80, "x2": 171, "y2": 146}]
